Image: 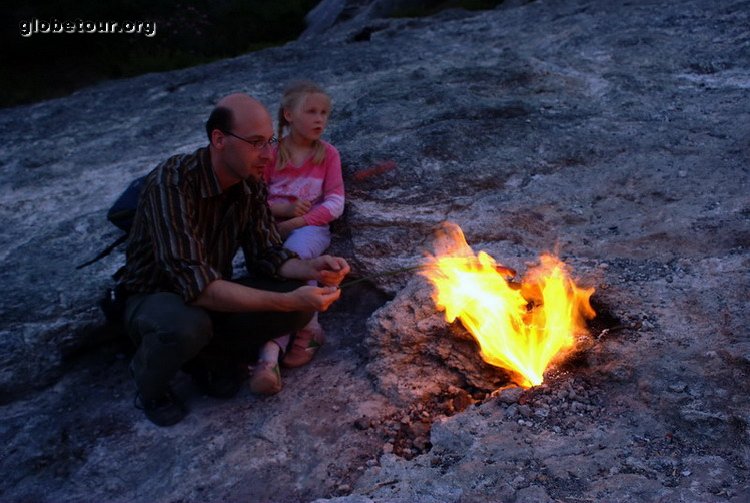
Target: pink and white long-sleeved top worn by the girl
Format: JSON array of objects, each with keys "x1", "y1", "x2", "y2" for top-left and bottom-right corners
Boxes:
[{"x1": 263, "y1": 140, "x2": 344, "y2": 225}]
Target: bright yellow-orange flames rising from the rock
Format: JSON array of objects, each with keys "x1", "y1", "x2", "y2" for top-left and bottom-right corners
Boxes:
[{"x1": 421, "y1": 224, "x2": 596, "y2": 388}]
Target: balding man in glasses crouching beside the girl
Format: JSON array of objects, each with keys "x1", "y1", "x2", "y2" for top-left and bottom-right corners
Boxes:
[{"x1": 118, "y1": 94, "x2": 350, "y2": 426}]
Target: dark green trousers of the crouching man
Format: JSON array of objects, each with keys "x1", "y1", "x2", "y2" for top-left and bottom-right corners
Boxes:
[{"x1": 125, "y1": 278, "x2": 314, "y2": 400}]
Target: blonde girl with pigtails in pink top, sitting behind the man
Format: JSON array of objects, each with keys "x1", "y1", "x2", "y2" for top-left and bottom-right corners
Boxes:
[{"x1": 250, "y1": 81, "x2": 344, "y2": 395}]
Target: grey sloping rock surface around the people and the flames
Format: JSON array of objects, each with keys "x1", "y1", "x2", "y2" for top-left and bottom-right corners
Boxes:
[{"x1": 0, "y1": 0, "x2": 750, "y2": 503}]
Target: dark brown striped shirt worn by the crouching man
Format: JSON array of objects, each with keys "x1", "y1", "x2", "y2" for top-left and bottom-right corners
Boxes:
[{"x1": 120, "y1": 147, "x2": 296, "y2": 302}]
